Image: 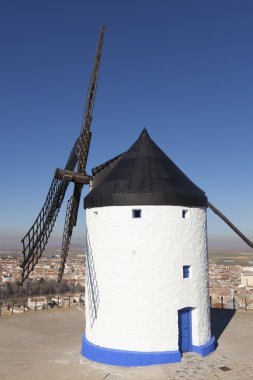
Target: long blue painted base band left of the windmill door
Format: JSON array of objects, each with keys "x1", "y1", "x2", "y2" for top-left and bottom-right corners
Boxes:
[{"x1": 81, "y1": 336, "x2": 181, "y2": 367}]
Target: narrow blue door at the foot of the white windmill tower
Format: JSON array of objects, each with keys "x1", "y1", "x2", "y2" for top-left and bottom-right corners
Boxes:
[{"x1": 178, "y1": 307, "x2": 192, "y2": 352}]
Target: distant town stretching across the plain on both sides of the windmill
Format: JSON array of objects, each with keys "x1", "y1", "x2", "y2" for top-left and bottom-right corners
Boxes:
[{"x1": 0, "y1": 248, "x2": 253, "y2": 310}]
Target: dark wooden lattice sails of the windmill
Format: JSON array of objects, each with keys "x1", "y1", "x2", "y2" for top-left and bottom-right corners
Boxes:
[{"x1": 20, "y1": 26, "x2": 104, "y2": 284}]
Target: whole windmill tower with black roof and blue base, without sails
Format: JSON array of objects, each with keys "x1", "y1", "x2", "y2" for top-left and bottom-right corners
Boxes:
[{"x1": 82, "y1": 130, "x2": 215, "y2": 366}]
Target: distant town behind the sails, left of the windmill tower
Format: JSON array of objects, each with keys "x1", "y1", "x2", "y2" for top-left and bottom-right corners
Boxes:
[{"x1": 0, "y1": 248, "x2": 85, "y2": 301}]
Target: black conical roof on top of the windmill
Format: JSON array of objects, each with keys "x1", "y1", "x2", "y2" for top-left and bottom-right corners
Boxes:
[{"x1": 84, "y1": 129, "x2": 207, "y2": 208}]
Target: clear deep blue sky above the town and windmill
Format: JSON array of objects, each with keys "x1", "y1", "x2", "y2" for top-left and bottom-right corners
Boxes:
[{"x1": 0, "y1": 0, "x2": 253, "y2": 250}]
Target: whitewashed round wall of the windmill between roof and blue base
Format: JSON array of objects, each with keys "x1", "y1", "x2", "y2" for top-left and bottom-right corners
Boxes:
[{"x1": 85, "y1": 206, "x2": 211, "y2": 351}]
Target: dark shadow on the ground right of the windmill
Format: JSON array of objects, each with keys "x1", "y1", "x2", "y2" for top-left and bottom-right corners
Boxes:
[{"x1": 211, "y1": 308, "x2": 236, "y2": 342}]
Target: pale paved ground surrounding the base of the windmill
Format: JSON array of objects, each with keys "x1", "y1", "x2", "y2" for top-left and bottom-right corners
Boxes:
[{"x1": 0, "y1": 308, "x2": 253, "y2": 380}]
